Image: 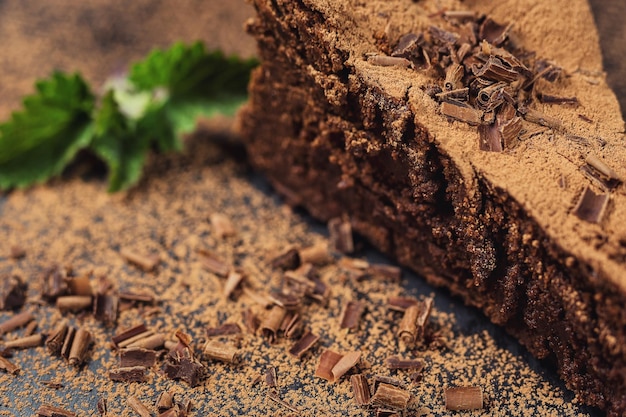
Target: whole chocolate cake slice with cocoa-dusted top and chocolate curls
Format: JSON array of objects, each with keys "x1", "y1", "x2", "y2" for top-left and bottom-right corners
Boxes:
[{"x1": 241, "y1": 0, "x2": 626, "y2": 416}]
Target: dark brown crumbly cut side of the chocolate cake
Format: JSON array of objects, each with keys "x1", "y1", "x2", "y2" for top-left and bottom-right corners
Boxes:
[{"x1": 241, "y1": 1, "x2": 626, "y2": 415}]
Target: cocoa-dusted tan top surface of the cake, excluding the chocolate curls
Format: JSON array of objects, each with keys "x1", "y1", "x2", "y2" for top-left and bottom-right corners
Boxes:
[{"x1": 296, "y1": 0, "x2": 626, "y2": 290}]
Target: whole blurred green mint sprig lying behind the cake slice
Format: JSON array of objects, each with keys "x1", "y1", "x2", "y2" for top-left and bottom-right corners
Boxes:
[{"x1": 0, "y1": 42, "x2": 256, "y2": 192}]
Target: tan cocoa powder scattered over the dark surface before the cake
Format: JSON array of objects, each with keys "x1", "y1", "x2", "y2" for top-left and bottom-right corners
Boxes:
[{"x1": 0, "y1": 128, "x2": 596, "y2": 416}]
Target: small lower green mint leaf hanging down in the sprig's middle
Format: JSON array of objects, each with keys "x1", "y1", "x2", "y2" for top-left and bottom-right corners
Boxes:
[{"x1": 90, "y1": 90, "x2": 150, "y2": 192}]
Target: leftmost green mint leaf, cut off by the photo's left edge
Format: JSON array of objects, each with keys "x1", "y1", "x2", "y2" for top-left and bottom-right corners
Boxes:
[{"x1": 0, "y1": 72, "x2": 95, "y2": 189}]
